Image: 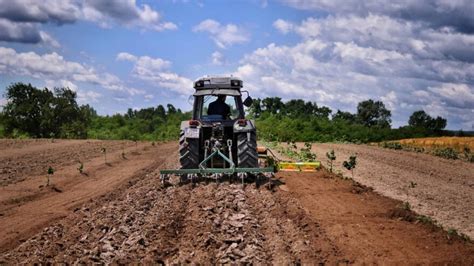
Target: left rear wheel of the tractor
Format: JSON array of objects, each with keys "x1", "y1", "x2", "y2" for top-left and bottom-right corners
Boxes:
[{"x1": 179, "y1": 130, "x2": 199, "y2": 169}]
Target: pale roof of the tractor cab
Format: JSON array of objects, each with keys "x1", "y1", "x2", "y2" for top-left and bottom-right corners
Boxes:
[{"x1": 194, "y1": 76, "x2": 242, "y2": 96}]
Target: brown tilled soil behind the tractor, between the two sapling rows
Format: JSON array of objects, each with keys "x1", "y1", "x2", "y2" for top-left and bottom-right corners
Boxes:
[{"x1": 0, "y1": 139, "x2": 474, "y2": 264}]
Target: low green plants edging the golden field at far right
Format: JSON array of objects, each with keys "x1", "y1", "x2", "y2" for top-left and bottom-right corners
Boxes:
[{"x1": 378, "y1": 141, "x2": 474, "y2": 163}]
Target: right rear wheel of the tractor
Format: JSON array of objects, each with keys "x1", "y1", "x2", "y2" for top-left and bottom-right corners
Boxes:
[{"x1": 237, "y1": 131, "x2": 258, "y2": 168}]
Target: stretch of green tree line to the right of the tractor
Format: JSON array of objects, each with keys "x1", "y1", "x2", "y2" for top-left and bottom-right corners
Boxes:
[{"x1": 249, "y1": 97, "x2": 452, "y2": 142}]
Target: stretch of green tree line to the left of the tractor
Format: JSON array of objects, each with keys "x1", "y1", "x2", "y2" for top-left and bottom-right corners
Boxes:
[{"x1": 0, "y1": 83, "x2": 191, "y2": 140}]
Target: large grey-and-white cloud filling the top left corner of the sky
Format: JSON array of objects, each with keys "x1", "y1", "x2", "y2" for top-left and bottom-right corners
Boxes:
[{"x1": 0, "y1": 0, "x2": 177, "y2": 45}]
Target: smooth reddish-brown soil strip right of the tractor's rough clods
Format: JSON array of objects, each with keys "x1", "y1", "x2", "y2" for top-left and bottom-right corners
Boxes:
[{"x1": 281, "y1": 171, "x2": 474, "y2": 264}]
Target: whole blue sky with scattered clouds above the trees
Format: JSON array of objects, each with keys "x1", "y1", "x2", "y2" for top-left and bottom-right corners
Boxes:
[{"x1": 0, "y1": 0, "x2": 474, "y2": 130}]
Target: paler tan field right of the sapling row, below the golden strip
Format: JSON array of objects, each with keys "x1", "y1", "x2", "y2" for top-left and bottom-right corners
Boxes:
[{"x1": 313, "y1": 144, "x2": 474, "y2": 239}]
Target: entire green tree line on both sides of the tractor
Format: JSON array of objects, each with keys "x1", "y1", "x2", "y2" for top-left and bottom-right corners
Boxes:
[{"x1": 0, "y1": 83, "x2": 449, "y2": 142}]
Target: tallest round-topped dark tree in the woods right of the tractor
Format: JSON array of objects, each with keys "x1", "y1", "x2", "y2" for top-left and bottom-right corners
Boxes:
[{"x1": 357, "y1": 99, "x2": 392, "y2": 128}]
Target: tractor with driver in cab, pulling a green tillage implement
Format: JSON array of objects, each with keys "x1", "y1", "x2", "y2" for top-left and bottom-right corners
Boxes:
[{"x1": 160, "y1": 76, "x2": 274, "y2": 182}]
